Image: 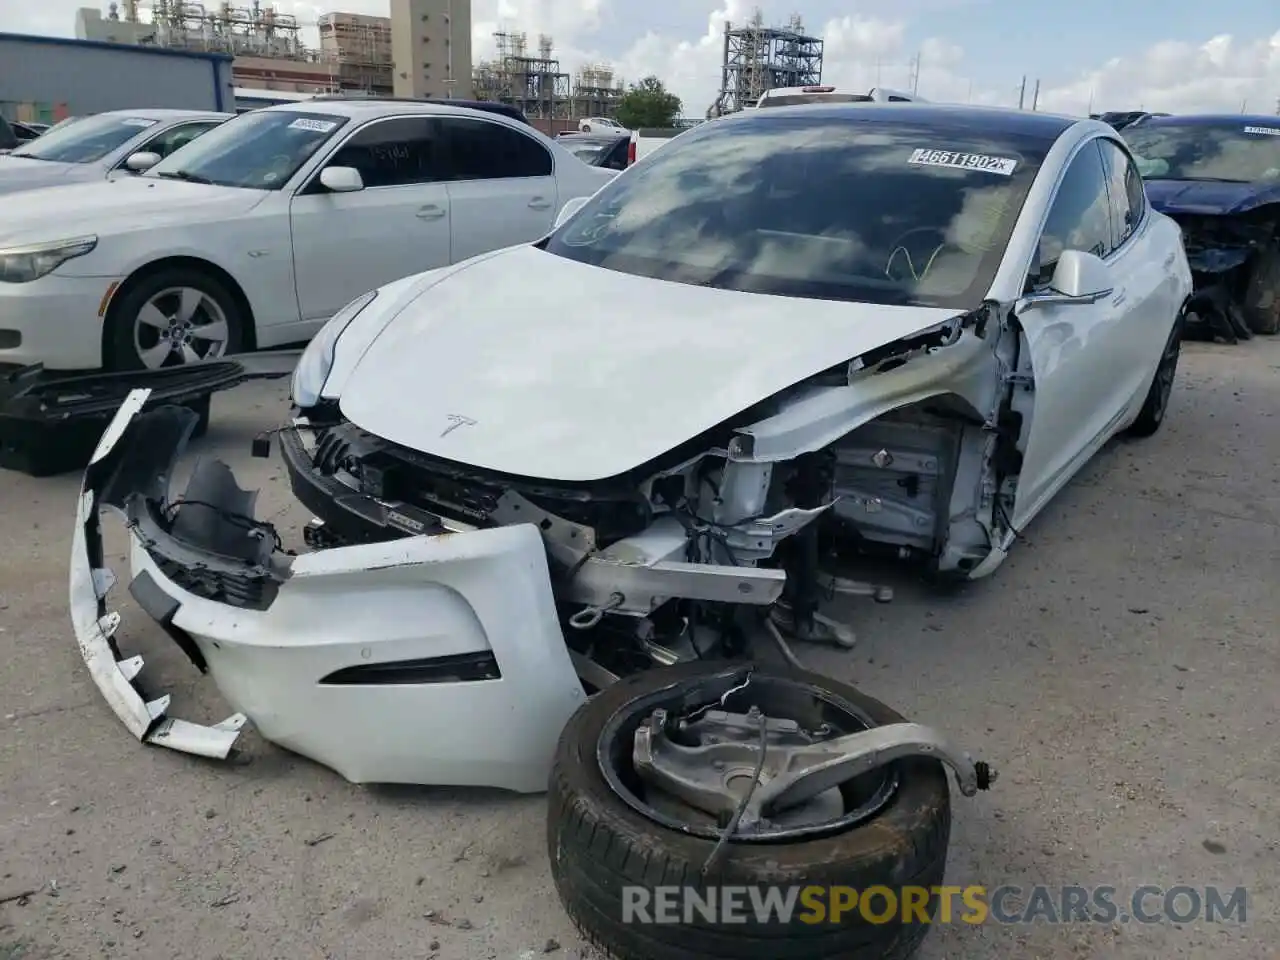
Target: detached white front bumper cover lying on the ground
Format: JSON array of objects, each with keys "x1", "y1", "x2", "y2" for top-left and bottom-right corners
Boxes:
[{"x1": 72, "y1": 392, "x2": 585, "y2": 792}]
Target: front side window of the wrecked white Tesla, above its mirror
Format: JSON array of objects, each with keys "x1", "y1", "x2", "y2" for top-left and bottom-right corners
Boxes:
[{"x1": 1028, "y1": 141, "x2": 1114, "y2": 287}]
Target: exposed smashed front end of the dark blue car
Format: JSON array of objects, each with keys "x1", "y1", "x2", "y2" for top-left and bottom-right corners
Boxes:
[{"x1": 1169, "y1": 204, "x2": 1280, "y2": 343}]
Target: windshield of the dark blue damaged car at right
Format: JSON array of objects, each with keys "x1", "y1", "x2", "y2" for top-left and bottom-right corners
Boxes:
[{"x1": 1124, "y1": 118, "x2": 1280, "y2": 183}]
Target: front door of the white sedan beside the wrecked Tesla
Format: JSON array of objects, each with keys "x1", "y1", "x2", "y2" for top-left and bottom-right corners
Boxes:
[{"x1": 289, "y1": 116, "x2": 452, "y2": 321}]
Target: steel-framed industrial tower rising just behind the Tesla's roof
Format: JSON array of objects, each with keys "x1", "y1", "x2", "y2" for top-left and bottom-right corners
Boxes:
[{"x1": 707, "y1": 8, "x2": 822, "y2": 119}]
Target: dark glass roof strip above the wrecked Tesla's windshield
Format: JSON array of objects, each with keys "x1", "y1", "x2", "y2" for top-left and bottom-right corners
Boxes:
[{"x1": 718, "y1": 102, "x2": 1080, "y2": 142}]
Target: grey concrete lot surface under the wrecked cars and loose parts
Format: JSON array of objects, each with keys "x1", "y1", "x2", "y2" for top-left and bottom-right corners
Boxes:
[{"x1": 0, "y1": 339, "x2": 1280, "y2": 960}]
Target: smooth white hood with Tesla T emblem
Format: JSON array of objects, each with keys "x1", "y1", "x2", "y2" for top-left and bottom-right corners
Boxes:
[{"x1": 340, "y1": 246, "x2": 956, "y2": 481}]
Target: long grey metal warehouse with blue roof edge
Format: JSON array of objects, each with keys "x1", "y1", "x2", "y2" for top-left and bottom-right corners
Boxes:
[{"x1": 0, "y1": 33, "x2": 236, "y2": 123}]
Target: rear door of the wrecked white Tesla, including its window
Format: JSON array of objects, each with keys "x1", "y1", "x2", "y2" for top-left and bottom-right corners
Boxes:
[{"x1": 1098, "y1": 138, "x2": 1181, "y2": 412}]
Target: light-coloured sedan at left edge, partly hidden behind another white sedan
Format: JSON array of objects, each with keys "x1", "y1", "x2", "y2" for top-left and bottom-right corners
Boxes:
[{"x1": 0, "y1": 110, "x2": 232, "y2": 195}]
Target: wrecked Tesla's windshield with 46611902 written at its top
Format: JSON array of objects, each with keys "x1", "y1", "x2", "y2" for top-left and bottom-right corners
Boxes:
[{"x1": 544, "y1": 111, "x2": 1050, "y2": 310}]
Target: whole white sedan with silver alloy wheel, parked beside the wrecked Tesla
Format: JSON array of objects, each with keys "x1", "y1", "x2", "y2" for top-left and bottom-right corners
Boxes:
[{"x1": 0, "y1": 100, "x2": 616, "y2": 370}]
